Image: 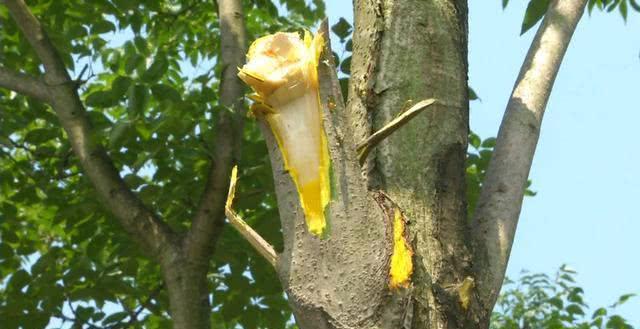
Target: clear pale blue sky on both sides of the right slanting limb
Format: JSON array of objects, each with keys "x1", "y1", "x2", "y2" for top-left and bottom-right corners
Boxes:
[{"x1": 327, "y1": 0, "x2": 640, "y2": 327}]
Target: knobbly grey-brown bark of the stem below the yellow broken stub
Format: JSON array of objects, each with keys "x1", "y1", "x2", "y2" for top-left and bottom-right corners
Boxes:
[{"x1": 263, "y1": 25, "x2": 402, "y2": 328}]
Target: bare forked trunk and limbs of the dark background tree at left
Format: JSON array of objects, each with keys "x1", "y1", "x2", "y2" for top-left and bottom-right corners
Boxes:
[{"x1": 0, "y1": 0, "x2": 246, "y2": 329}]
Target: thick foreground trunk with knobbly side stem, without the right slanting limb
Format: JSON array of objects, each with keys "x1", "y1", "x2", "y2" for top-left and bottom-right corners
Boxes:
[{"x1": 263, "y1": 0, "x2": 489, "y2": 329}]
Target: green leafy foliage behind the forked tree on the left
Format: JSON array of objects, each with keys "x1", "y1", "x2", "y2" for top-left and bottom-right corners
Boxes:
[{"x1": 0, "y1": 0, "x2": 324, "y2": 328}]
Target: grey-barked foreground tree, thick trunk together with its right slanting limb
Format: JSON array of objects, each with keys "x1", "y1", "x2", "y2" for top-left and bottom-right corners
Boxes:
[{"x1": 264, "y1": 0, "x2": 586, "y2": 329}]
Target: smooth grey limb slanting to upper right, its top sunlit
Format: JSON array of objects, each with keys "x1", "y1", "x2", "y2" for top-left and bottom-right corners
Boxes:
[{"x1": 473, "y1": 0, "x2": 587, "y2": 310}]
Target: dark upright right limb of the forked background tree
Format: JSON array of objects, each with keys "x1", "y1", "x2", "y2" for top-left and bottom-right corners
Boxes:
[{"x1": 186, "y1": 0, "x2": 247, "y2": 261}]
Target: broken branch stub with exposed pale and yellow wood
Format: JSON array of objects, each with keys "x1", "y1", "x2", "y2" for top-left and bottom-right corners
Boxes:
[{"x1": 238, "y1": 32, "x2": 331, "y2": 236}]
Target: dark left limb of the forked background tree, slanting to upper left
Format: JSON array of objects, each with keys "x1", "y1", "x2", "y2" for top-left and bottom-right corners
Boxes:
[{"x1": 2, "y1": 0, "x2": 176, "y2": 257}]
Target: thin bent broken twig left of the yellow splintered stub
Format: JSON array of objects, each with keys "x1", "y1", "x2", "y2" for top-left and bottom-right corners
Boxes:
[{"x1": 224, "y1": 167, "x2": 278, "y2": 268}]
